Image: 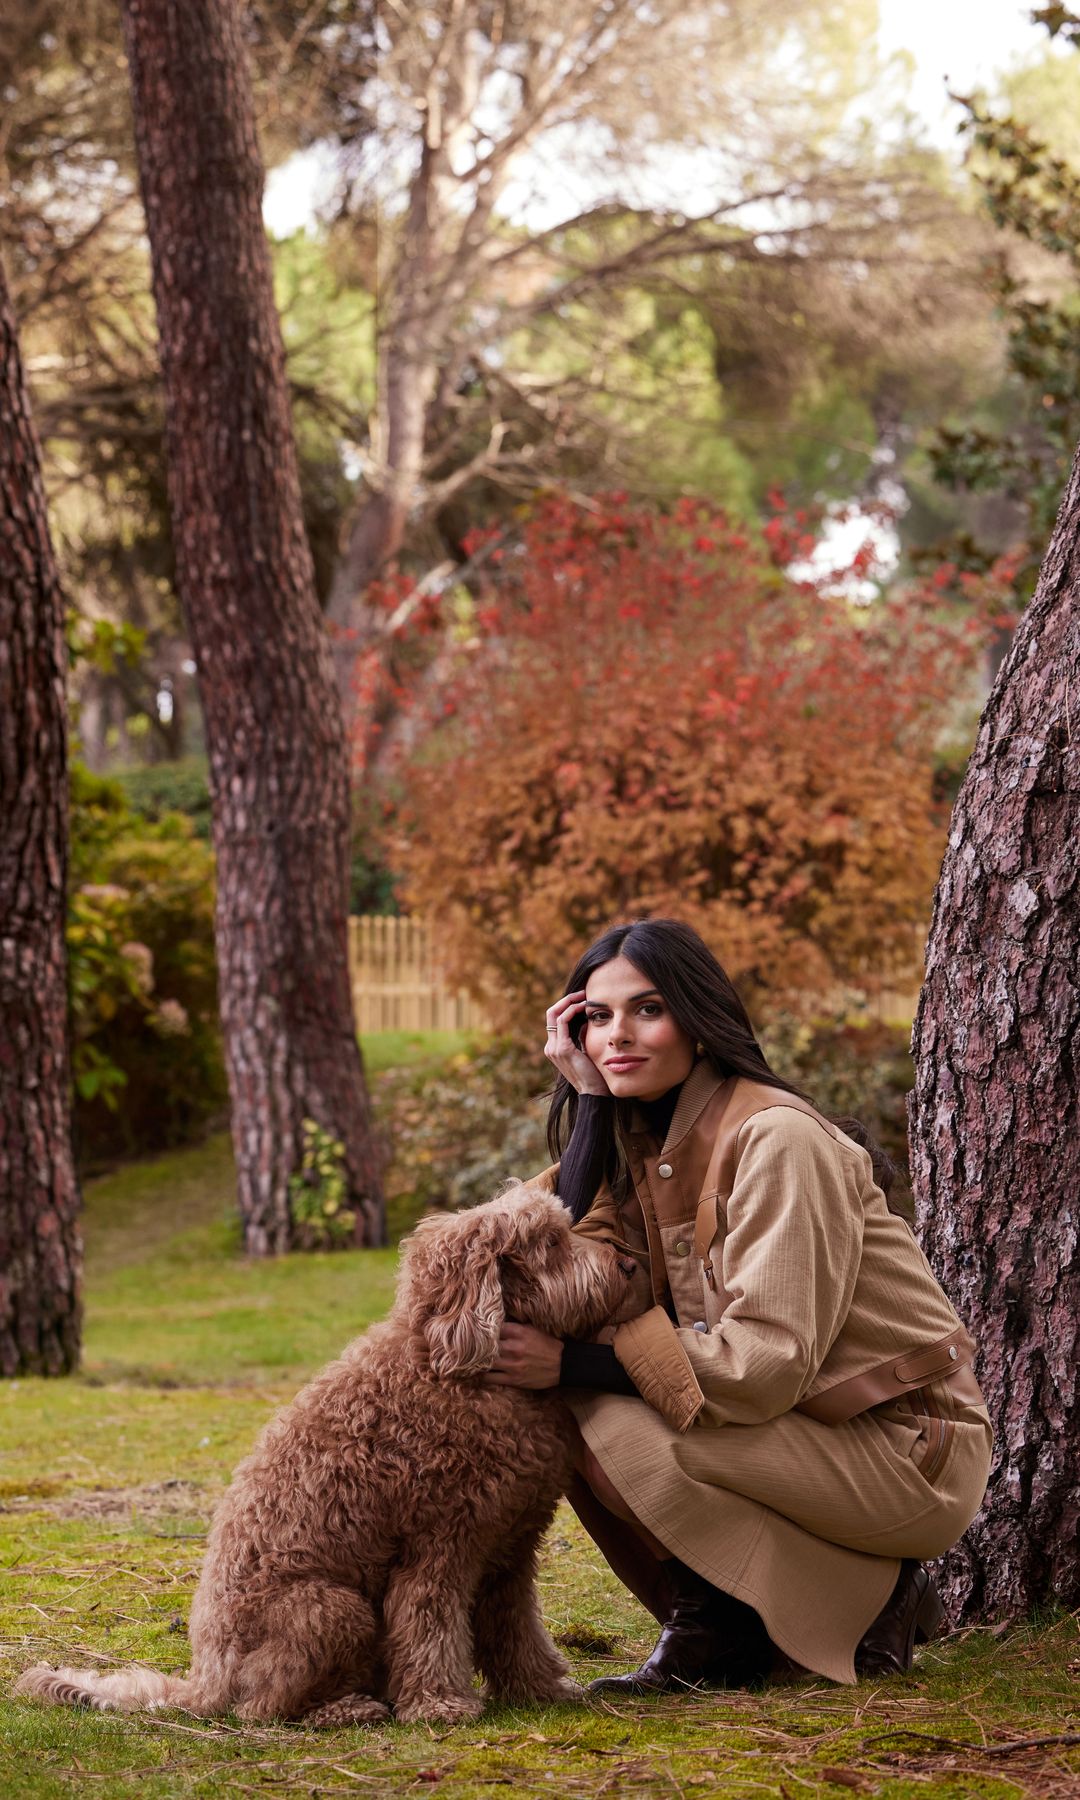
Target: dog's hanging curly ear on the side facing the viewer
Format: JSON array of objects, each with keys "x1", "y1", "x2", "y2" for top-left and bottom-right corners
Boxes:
[{"x1": 410, "y1": 1208, "x2": 506, "y2": 1375}]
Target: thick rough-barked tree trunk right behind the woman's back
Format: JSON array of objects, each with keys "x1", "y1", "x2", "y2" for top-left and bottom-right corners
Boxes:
[{"x1": 911, "y1": 439, "x2": 1080, "y2": 1620}]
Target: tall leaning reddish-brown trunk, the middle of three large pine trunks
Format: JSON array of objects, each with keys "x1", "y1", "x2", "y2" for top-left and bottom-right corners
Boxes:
[{"x1": 124, "y1": 0, "x2": 385, "y2": 1255}]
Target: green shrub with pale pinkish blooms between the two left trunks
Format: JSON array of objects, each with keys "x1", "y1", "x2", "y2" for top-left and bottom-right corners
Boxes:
[{"x1": 67, "y1": 765, "x2": 225, "y2": 1166}]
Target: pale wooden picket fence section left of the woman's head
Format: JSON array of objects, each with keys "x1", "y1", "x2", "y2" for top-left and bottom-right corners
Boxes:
[{"x1": 349, "y1": 913, "x2": 488, "y2": 1037}]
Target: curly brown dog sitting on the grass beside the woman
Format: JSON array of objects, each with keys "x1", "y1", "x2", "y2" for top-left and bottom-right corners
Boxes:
[{"x1": 16, "y1": 1186, "x2": 634, "y2": 1724}]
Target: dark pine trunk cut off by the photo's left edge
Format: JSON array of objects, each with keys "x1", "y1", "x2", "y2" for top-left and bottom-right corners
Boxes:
[{"x1": 0, "y1": 257, "x2": 83, "y2": 1377}]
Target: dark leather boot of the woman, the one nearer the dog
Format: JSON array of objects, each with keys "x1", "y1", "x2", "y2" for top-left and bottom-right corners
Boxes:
[{"x1": 585, "y1": 1557, "x2": 772, "y2": 1696}]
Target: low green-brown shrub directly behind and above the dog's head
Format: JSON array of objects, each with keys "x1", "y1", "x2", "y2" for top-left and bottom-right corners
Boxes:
[{"x1": 371, "y1": 1042, "x2": 549, "y2": 1237}]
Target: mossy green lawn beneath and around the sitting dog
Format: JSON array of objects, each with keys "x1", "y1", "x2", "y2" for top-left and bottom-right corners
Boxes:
[{"x1": 0, "y1": 1044, "x2": 1080, "y2": 1800}]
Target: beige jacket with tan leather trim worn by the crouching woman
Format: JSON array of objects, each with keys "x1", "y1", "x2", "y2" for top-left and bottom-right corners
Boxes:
[{"x1": 538, "y1": 1062, "x2": 977, "y2": 1431}]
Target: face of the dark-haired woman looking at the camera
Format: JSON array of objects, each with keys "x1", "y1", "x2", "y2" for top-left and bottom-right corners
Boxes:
[{"x1": 581, "y1": 956, "x2": 695, "y2": 1100}]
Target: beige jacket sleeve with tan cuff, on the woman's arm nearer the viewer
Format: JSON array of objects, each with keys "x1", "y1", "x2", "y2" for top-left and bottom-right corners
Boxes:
[{"x1": 616, "y1": 1107, "x2": 862, "y2": 1431}]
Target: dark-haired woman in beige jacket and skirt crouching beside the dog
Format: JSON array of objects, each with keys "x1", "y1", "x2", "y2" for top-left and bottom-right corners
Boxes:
[{"x1": 490, "y1": 920, "x2": 990, "y2": 1694}]
